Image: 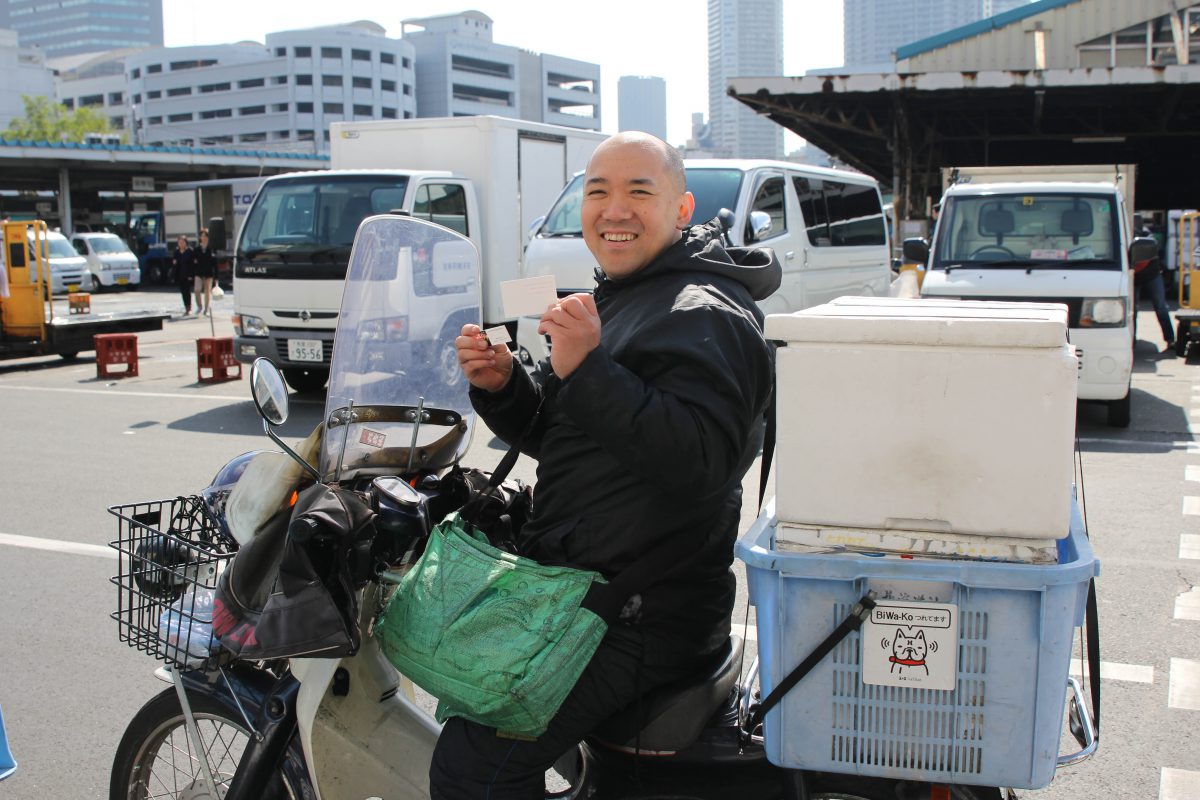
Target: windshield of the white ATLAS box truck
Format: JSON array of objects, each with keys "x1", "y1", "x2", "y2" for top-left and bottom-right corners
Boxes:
[{"x1": 238, "y1": 175, "x2": 408, "y2": 258}]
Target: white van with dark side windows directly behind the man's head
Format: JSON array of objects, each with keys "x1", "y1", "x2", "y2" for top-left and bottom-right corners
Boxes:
[{"x1": 517, "y1": 158, "x2": 892, "y2": 363}]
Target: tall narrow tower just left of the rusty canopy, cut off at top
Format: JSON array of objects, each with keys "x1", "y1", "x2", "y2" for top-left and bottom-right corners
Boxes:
[{"x1": 708, "y1": 0, "x2": 784, "y2": 158}]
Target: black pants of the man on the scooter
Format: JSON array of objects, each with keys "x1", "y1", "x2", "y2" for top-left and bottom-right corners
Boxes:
[{"x1": 430, "y1": 625, "x2": 696, "y2": 800}]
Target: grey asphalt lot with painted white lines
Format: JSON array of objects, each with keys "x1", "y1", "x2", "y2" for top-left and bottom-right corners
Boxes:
[{"x1": 0, "y1": 284, "x2": 1200, "y2": 800}]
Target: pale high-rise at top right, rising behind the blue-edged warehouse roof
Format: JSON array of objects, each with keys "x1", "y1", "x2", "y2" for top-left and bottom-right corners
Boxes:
[{"x1": 842, "y1": 0, "x2": 1031, "y2": 72}]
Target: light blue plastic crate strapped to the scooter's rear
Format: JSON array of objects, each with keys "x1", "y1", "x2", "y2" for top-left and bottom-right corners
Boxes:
[{"x1": 736, "y1": 496, "x2": 1099, "y2": 789}]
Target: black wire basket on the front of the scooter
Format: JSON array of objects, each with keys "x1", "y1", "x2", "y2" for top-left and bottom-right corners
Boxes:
[{"x1": 108, "y1": 495, "x2": 236, "y2": 669}]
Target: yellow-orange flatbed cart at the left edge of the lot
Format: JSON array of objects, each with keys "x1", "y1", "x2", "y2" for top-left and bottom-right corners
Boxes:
[{"x1": 0, "y1": 221, "x2": 169, "y2": 360}]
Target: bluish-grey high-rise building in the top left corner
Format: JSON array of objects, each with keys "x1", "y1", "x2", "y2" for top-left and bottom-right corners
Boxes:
[{"x1": 0, "y1": 0, "x2": 163, "y2": 58}]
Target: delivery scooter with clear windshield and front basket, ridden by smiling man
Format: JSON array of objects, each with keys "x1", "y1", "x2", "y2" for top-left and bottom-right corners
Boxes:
[{"x1": 109, "y1": 216, "x2": 1089, "y2": 800}]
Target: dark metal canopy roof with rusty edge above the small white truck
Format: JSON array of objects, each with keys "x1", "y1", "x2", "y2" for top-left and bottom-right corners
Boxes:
[{"x1": 728, "y1": 65, "x2": 1200, "y2": 212}]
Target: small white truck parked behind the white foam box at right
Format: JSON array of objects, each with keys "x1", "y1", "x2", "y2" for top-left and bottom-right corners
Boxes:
[{"x1": 905, "y1": 166, "x2": 1157, "y2": 427}]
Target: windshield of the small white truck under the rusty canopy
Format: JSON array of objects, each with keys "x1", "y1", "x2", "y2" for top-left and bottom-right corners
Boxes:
[{"x1": 932, "y1": 192, "x2": 1121, "y2": 270}]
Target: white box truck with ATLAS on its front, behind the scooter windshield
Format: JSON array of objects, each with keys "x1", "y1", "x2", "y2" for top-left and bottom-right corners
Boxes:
[{"x1": 234, "y1": 116, "x2": 605, "y2": 391}]
